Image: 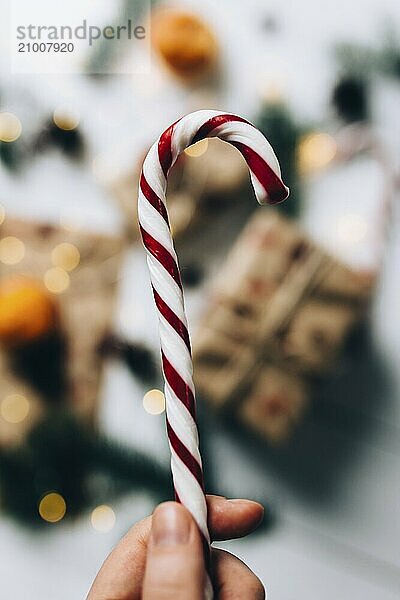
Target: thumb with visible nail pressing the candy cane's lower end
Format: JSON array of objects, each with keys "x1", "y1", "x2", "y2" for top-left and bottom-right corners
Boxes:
[{"x1": 143, "y1": 502, "x2": 205, "y2": 600}]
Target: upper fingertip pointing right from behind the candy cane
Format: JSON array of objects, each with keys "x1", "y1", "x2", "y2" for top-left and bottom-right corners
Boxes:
[{"x1": 207, "y1": 496, "x2": 264, "y2": 540}]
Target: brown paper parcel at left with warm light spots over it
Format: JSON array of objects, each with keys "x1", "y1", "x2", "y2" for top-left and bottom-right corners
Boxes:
[{"x1": 0, "y1": 217, "x2": 124, "y2": 446}]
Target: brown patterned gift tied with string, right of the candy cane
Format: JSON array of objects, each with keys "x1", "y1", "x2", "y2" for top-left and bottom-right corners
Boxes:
[{"x1": 193, "y1": 210, "x2": 374, "y2": 442}]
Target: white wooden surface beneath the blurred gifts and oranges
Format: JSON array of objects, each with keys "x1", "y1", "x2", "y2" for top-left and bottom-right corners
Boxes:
[{"x1": 0, "y1": 0, "x2": 400, "y2": 600}]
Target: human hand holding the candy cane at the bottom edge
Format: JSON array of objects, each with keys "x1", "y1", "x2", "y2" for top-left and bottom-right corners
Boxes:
[{"x1": 87, "y1": 496, "x2": 265, "y2": 600}]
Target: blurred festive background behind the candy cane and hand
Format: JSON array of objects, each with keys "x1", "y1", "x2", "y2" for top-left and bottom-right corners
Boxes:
[{"x1": 0, "y1": 0, "x2": 400, "y2": 600}]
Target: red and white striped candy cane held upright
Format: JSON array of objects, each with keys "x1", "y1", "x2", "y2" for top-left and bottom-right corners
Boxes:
[{"x1": 138, "y1": 110, "x2": 289, "y2": 592}]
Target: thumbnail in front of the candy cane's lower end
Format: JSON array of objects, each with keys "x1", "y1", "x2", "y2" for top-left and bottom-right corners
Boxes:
[{"x1": 151, "y1": 502, "x2": 190, "y2": 546}]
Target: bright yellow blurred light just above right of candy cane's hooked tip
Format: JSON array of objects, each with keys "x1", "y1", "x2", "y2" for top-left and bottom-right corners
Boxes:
[{"x1": 297, "y1": 132, "x2": 337, "y2": 174}]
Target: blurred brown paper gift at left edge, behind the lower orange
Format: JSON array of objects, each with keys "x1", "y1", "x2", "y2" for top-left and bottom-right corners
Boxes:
[{"x1": 0, "y1": 217, "x2": 125, "y2": 447}]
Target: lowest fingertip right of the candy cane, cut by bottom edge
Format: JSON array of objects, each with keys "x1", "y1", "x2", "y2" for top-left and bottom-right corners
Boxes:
[{"x1": 211, "y1": 548, "x2": 265, "y2": 600}]
